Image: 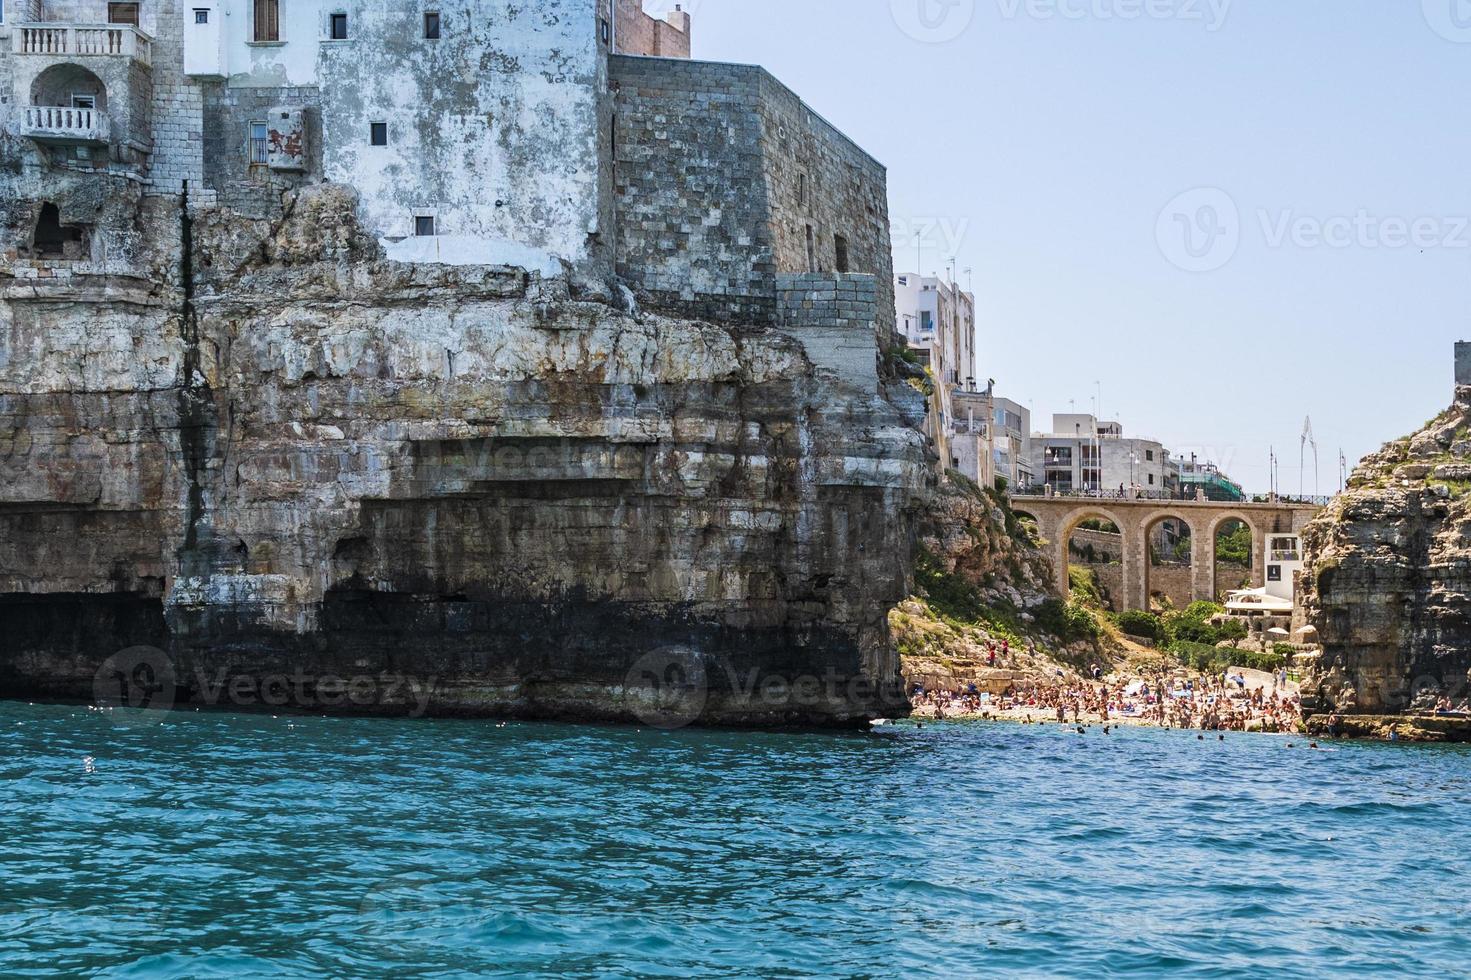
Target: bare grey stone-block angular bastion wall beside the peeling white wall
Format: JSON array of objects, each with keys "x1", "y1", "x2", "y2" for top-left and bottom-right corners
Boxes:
[{"x1": 610, "y1": 57, "x2": 894, "y2": 330}]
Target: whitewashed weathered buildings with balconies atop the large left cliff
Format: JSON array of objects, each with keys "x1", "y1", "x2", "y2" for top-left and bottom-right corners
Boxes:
[{"x1": 0, "y1": 0, "x2": 690, "y2": 272}]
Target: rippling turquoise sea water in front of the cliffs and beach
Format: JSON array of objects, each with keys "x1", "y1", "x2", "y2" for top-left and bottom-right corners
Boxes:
[{"x1": 0, "y1": 705, "x2": 1471, "y2": 977}]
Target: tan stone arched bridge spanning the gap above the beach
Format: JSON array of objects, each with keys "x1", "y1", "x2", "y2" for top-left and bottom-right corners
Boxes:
[{"x1": 1011, "y1": 493, "x2": 1322, "y2": 609}]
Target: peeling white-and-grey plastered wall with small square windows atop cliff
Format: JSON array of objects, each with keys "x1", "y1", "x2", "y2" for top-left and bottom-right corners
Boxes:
[{"x1": 318, "y1": 0, "x2": 606, "y2": 263}]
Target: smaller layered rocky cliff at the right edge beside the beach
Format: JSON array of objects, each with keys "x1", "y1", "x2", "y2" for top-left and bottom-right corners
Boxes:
[{"x1": 1300, "y1": 387, "x2": 1471, "y2": 715}]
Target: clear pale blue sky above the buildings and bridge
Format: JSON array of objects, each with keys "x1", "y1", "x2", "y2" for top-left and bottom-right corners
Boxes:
[{"x1": 685, "y1": 0, "x2": 1471, "y2": 493}]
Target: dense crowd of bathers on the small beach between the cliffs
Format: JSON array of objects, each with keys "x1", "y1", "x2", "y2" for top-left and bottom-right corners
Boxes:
[{"x1": 911, "y1": 671, "x2": 1302, "y2": 731}]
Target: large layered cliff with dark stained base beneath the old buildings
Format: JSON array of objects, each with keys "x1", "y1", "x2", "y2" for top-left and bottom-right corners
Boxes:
[{"x1": 0, "y1": 184, "x2": 927, "y2": 725}]
